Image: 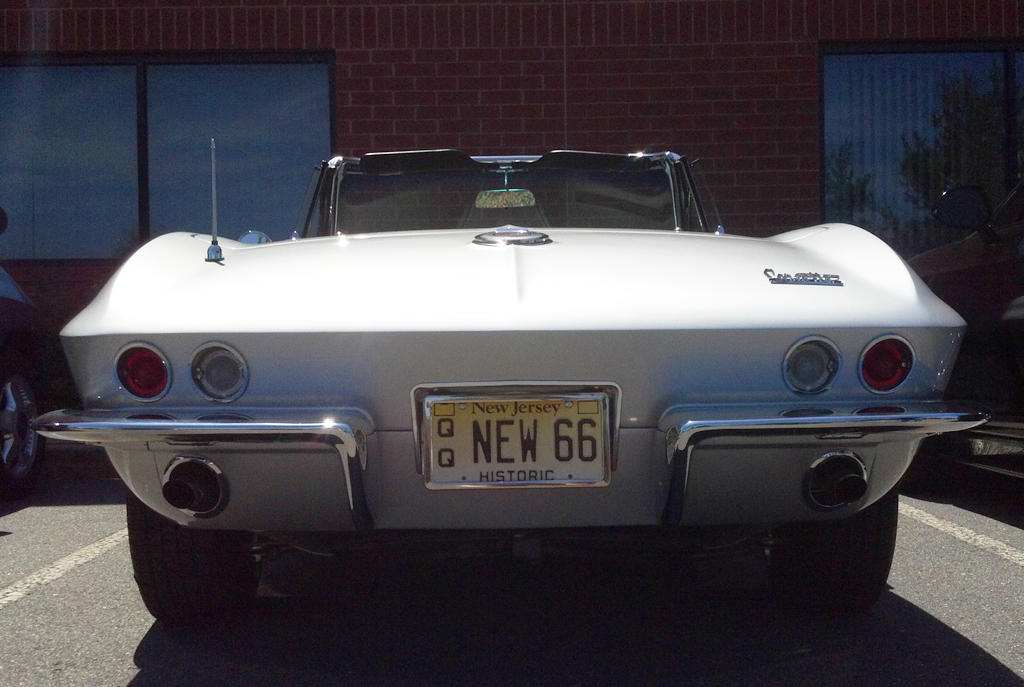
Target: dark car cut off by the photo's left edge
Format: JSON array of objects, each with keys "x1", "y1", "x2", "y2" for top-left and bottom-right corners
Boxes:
[{"x1": 0, "y1": 208, "x2": 43, "y2": 501}]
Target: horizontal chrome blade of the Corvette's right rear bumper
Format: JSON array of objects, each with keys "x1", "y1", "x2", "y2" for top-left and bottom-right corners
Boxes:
[{"x1": 658, "y1": 401, "x2": 989, "y2": 463}]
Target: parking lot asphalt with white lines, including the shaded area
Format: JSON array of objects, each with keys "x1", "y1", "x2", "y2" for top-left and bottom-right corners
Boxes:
[{"x1": 0, "y1": 446, "x2": 1024, "y2": 687}]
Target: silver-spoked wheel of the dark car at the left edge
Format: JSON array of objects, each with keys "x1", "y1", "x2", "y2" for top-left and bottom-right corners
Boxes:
[{"x1": 0, "y1": 360, "x2": 43, "y2": 501}]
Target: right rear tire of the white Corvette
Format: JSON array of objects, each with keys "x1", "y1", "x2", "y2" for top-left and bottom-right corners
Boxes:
[{"x1": 769, "y1": 489, "x2": 899, "y2": 613}]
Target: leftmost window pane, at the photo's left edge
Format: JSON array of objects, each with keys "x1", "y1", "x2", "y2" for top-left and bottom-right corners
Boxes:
[{"x1": 0, "y1": 67, "x2": 139, "y2": 259}]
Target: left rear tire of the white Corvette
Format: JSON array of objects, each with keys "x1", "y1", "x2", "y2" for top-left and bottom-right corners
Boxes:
[{"x1": 127, "y1": 492, "x2": 262, "y2": 627}]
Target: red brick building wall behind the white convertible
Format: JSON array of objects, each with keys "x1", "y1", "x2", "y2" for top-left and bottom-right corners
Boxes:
[{"x1": 0, "y1": 0, "x2": 1024, "y2": 327}]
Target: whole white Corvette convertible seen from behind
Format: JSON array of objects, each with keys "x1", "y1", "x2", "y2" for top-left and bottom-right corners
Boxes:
[{"x1": 37, "y1": 151, "x2": 985, "y2": 624}]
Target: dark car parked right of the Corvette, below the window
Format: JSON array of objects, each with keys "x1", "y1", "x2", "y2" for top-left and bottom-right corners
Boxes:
[{"x1": 908, "y1": 181, "x2": 1024, "y2": 478}]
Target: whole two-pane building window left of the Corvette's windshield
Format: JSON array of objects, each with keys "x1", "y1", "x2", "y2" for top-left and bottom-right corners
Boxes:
[{"x1": 0, "y1": 56, "x2": 331, "y2": 259}]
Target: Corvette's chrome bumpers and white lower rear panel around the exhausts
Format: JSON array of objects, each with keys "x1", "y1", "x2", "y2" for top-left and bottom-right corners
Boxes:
[{"x1": 36, "y1": 401, "x2": 988, "y2": 531}]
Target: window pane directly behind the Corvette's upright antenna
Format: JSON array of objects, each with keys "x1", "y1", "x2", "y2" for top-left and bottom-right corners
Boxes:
[{"x1": 147, "y1": 65, "x2": 331, "y2": 241}]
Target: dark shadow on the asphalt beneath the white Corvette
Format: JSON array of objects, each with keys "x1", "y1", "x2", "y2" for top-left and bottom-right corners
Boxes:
[{"x1": 131, "y1": 555, "x2": 1024, "y2": 687}]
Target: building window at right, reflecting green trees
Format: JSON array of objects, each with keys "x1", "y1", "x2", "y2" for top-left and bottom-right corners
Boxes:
[{"x1": 822, "y1": 50, "x2": 1022, "y2": 257}]
